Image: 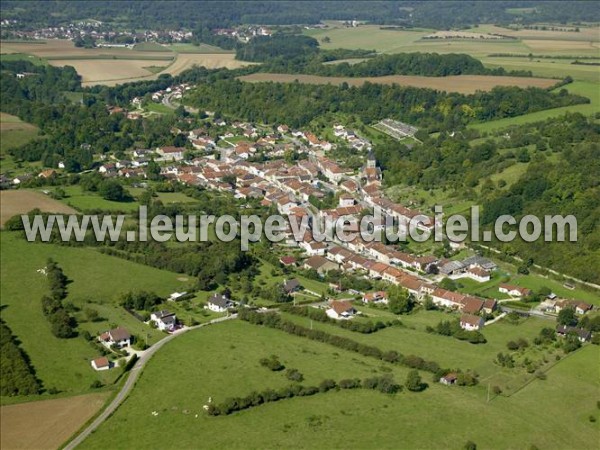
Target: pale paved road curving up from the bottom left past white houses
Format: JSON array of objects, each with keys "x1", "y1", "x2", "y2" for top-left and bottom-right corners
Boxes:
[{"x1": 64, "y1": 314, "x2": 237, "y2": 450}]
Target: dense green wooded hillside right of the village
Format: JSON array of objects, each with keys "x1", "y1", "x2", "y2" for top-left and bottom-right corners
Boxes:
[{"x1": 375, "y1": 114, "x2": 600, "y2": 283}]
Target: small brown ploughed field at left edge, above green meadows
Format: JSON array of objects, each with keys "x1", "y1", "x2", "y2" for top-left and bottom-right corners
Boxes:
[{"x1": 0, "y1": 190, "x2": 76, "y2": 226}]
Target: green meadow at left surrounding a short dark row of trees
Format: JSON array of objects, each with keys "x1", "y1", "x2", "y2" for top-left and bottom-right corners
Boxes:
[{"x1": 0, "y1": 231, "x2": 188, "y2": 395}]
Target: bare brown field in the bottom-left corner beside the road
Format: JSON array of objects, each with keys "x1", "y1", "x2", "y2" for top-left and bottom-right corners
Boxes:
[{"x1": 0, "y1": 393, "x2": 107, "y2": 449}]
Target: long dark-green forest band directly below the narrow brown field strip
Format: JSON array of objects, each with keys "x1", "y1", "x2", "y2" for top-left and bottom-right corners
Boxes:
[{"x1": 189, "y1": 79, "x2": 589, "y2": 131}]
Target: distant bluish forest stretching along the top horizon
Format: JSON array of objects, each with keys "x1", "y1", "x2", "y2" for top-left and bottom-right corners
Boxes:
[{"x1": 1, "y1": 0, "x2": 600, "y2": 30}]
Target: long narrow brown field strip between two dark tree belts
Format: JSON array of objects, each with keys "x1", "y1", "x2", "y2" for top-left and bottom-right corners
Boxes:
[{"x1": 240, "y1": 73, "x2": 556, "y2": 94}]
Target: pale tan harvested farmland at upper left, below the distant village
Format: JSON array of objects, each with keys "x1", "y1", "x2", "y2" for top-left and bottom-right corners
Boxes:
[{"x1": 0, "y1": 40, "x2": 250, "y2": 86}]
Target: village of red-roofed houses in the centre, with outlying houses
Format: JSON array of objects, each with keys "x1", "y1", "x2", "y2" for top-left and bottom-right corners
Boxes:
[{"x1": 76, "y1": 84, "x2": 592, "y2": 374}]
